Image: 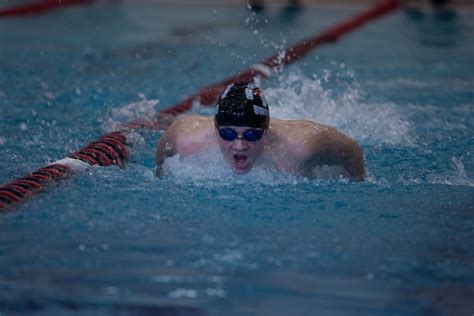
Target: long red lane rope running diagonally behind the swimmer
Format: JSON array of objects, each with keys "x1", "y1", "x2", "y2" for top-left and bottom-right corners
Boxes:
[{"x1": 0, "y1": 0, "x2": 400, "y2": 213}]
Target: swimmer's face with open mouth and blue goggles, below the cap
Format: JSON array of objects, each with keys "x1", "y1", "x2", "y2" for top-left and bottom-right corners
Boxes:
[{"x1": 216, "y1": 126, "x2": 264, "y2": 174}]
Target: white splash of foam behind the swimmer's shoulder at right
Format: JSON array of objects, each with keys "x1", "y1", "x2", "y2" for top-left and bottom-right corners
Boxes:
[{"x1": 264, "y1": 68, "x2": 413, "y2": 145}]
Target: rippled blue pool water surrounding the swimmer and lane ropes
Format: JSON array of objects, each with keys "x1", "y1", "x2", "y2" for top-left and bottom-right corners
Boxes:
[{"x1": 0, "y1": 1, "x2": 474, "y2": 315}]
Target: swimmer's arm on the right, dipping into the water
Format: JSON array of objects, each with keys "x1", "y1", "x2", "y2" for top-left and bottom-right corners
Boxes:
[{"x1": 308, "y1": 127, "x2": 365, "y2": 181}]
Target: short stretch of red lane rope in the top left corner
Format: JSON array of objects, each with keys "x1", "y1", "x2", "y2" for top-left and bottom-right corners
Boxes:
[{"x1": 0, "y1": 0, "x2": 93, "y2": 17}]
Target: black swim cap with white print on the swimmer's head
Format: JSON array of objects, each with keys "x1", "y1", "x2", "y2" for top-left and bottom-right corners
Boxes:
[{"x1": 215, "y1": 82, "x2": 270, "y2": 128}]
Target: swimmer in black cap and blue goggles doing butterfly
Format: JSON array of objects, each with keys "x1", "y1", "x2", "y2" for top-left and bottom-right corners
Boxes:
[{"x1": 156, "y1": 83, "x2": 365, "y2": 181}]
